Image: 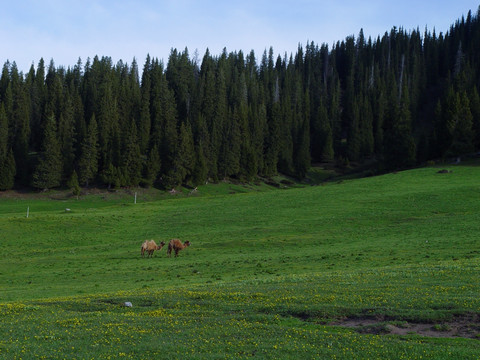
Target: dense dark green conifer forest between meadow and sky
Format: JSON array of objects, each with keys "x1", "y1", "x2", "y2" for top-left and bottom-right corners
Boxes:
[{"x1": 0, "y1": 9, "x2": 480, "y2": 190}]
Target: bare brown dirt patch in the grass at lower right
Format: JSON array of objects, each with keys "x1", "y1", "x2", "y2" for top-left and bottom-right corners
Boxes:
[{"x1": 329, "y1": 314, "x2": 480, "y2": 340}]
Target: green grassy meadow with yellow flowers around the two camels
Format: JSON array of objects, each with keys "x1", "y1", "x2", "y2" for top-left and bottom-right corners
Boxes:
[{"x1": 0, "y1": 164, "x2": 480, "y2": 359}]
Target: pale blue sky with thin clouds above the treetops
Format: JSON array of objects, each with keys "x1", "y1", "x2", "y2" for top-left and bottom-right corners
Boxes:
[{"x1": 0, "y1": 0, "x2": 480, "y2": 73}]
